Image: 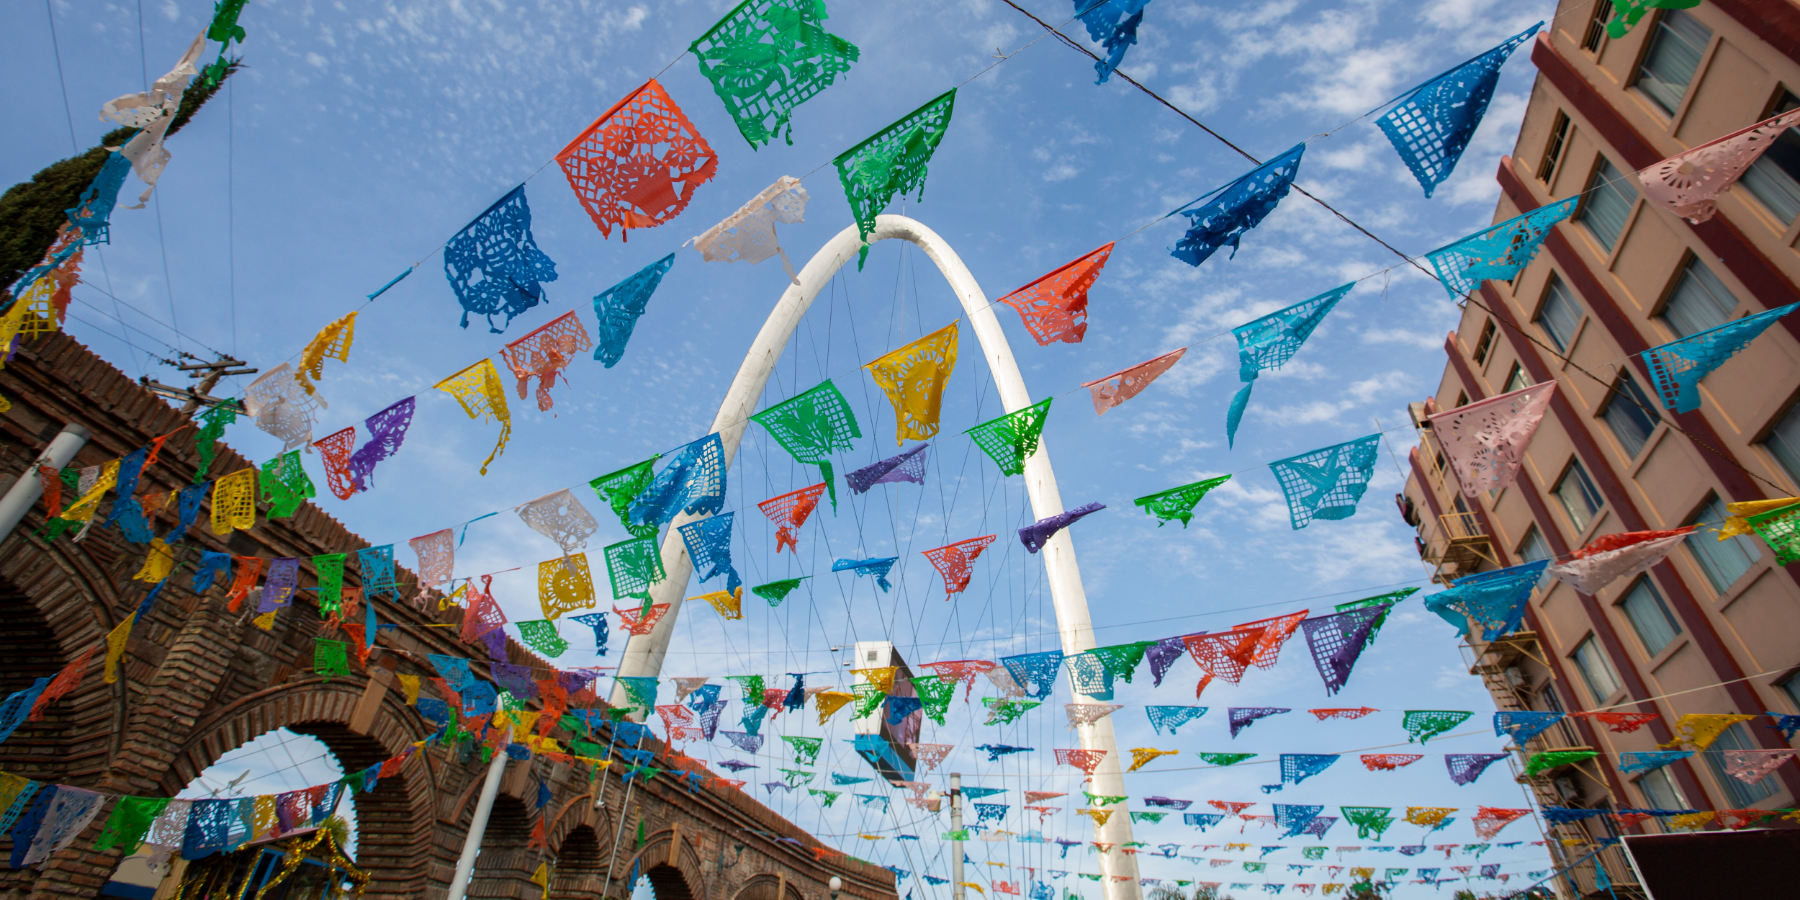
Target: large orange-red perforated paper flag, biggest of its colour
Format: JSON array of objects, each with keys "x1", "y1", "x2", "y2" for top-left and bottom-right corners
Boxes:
[{"x1": 556, "y1": 79, "x2": 718, "y2": 239}]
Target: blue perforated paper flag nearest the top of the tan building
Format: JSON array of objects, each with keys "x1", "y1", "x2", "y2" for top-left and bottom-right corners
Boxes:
[{"x1": 1375, "y1": 22, "x2": 1544, "y2": 196}]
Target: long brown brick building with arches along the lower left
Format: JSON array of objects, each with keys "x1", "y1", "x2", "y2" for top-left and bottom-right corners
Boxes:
[{"x1": 0, "y1": 335, "x2": 895, "y2": 900}]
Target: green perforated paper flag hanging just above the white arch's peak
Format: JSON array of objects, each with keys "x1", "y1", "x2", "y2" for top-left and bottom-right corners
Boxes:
[{"x1": 832, "y1": 88, "x2": 956, "y2": 272}]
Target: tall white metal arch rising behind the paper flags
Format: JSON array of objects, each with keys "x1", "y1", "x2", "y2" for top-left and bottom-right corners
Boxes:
[{"x1": 614, "y1": 216, "x2": 1141, "y2": 900}]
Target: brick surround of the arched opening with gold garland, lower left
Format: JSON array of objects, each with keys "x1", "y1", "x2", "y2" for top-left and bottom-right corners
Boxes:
[{"x1": 162, "y1": 679, "x2": 434, "y2": 900}]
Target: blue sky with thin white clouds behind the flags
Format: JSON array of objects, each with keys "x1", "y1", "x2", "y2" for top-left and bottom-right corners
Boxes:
[{"x1": 0, "y1": 0, "x2": 1553, "y2": 896}]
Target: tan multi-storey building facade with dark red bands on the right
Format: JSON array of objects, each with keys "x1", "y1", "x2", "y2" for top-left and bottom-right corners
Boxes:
[{"x1": 1399, "y1": 0, "x2": 1800, "y2": 895}]
